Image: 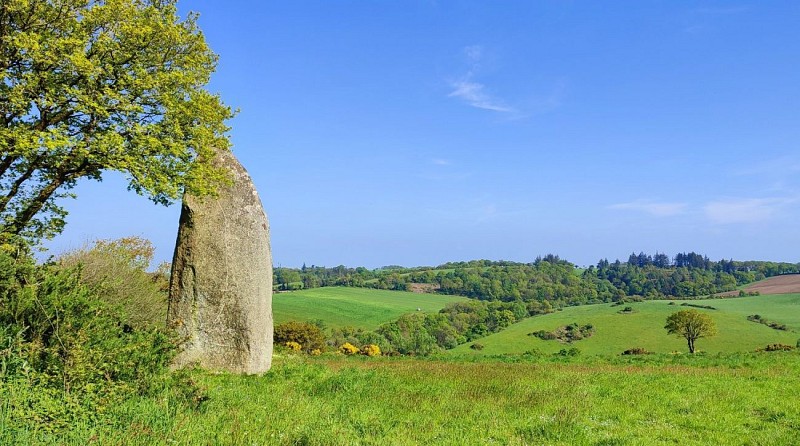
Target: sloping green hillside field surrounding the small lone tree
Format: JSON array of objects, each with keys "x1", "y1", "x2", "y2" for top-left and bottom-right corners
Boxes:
[{"x1": 449, "y1": 294, "x2": 800, "y2": 355}]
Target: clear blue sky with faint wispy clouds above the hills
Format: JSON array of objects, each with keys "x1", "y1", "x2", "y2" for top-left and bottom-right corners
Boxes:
[{"x1": 49, "y1": 0, "x2": 800, "y2": 268}]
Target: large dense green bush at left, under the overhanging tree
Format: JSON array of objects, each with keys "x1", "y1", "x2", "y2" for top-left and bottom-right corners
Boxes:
[{"x1": 0, "y1": 246, "x2": 192, "y2": 432}]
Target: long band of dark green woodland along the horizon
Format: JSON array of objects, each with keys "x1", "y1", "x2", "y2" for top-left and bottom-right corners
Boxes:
[{"x1": 274, "y1": 252, "x2": 800, "y2": 307}]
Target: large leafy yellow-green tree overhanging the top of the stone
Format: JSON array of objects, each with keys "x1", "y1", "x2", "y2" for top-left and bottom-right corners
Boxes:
[{"x1": 0, "y1": 0, "x2": 233, "y2": 240}]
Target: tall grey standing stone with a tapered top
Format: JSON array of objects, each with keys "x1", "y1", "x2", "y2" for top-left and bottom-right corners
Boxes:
[{"x1": 167, "y1": 151, "x2": 272, "y2": 374}]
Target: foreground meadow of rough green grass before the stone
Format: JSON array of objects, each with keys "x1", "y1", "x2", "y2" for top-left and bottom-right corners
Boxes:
[{"x1": 15, "y1": 352, "x2": 800, "y2": 445}]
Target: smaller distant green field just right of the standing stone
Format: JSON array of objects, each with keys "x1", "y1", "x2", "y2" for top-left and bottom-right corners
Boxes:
[{"x1": 272, "y1": 287, "x2": 465, "y2": 330}]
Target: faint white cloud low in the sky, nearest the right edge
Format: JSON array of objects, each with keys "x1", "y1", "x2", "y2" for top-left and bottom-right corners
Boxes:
[{"x1": 703, "y1": 198, "x2": 797, "y2": 224}]
